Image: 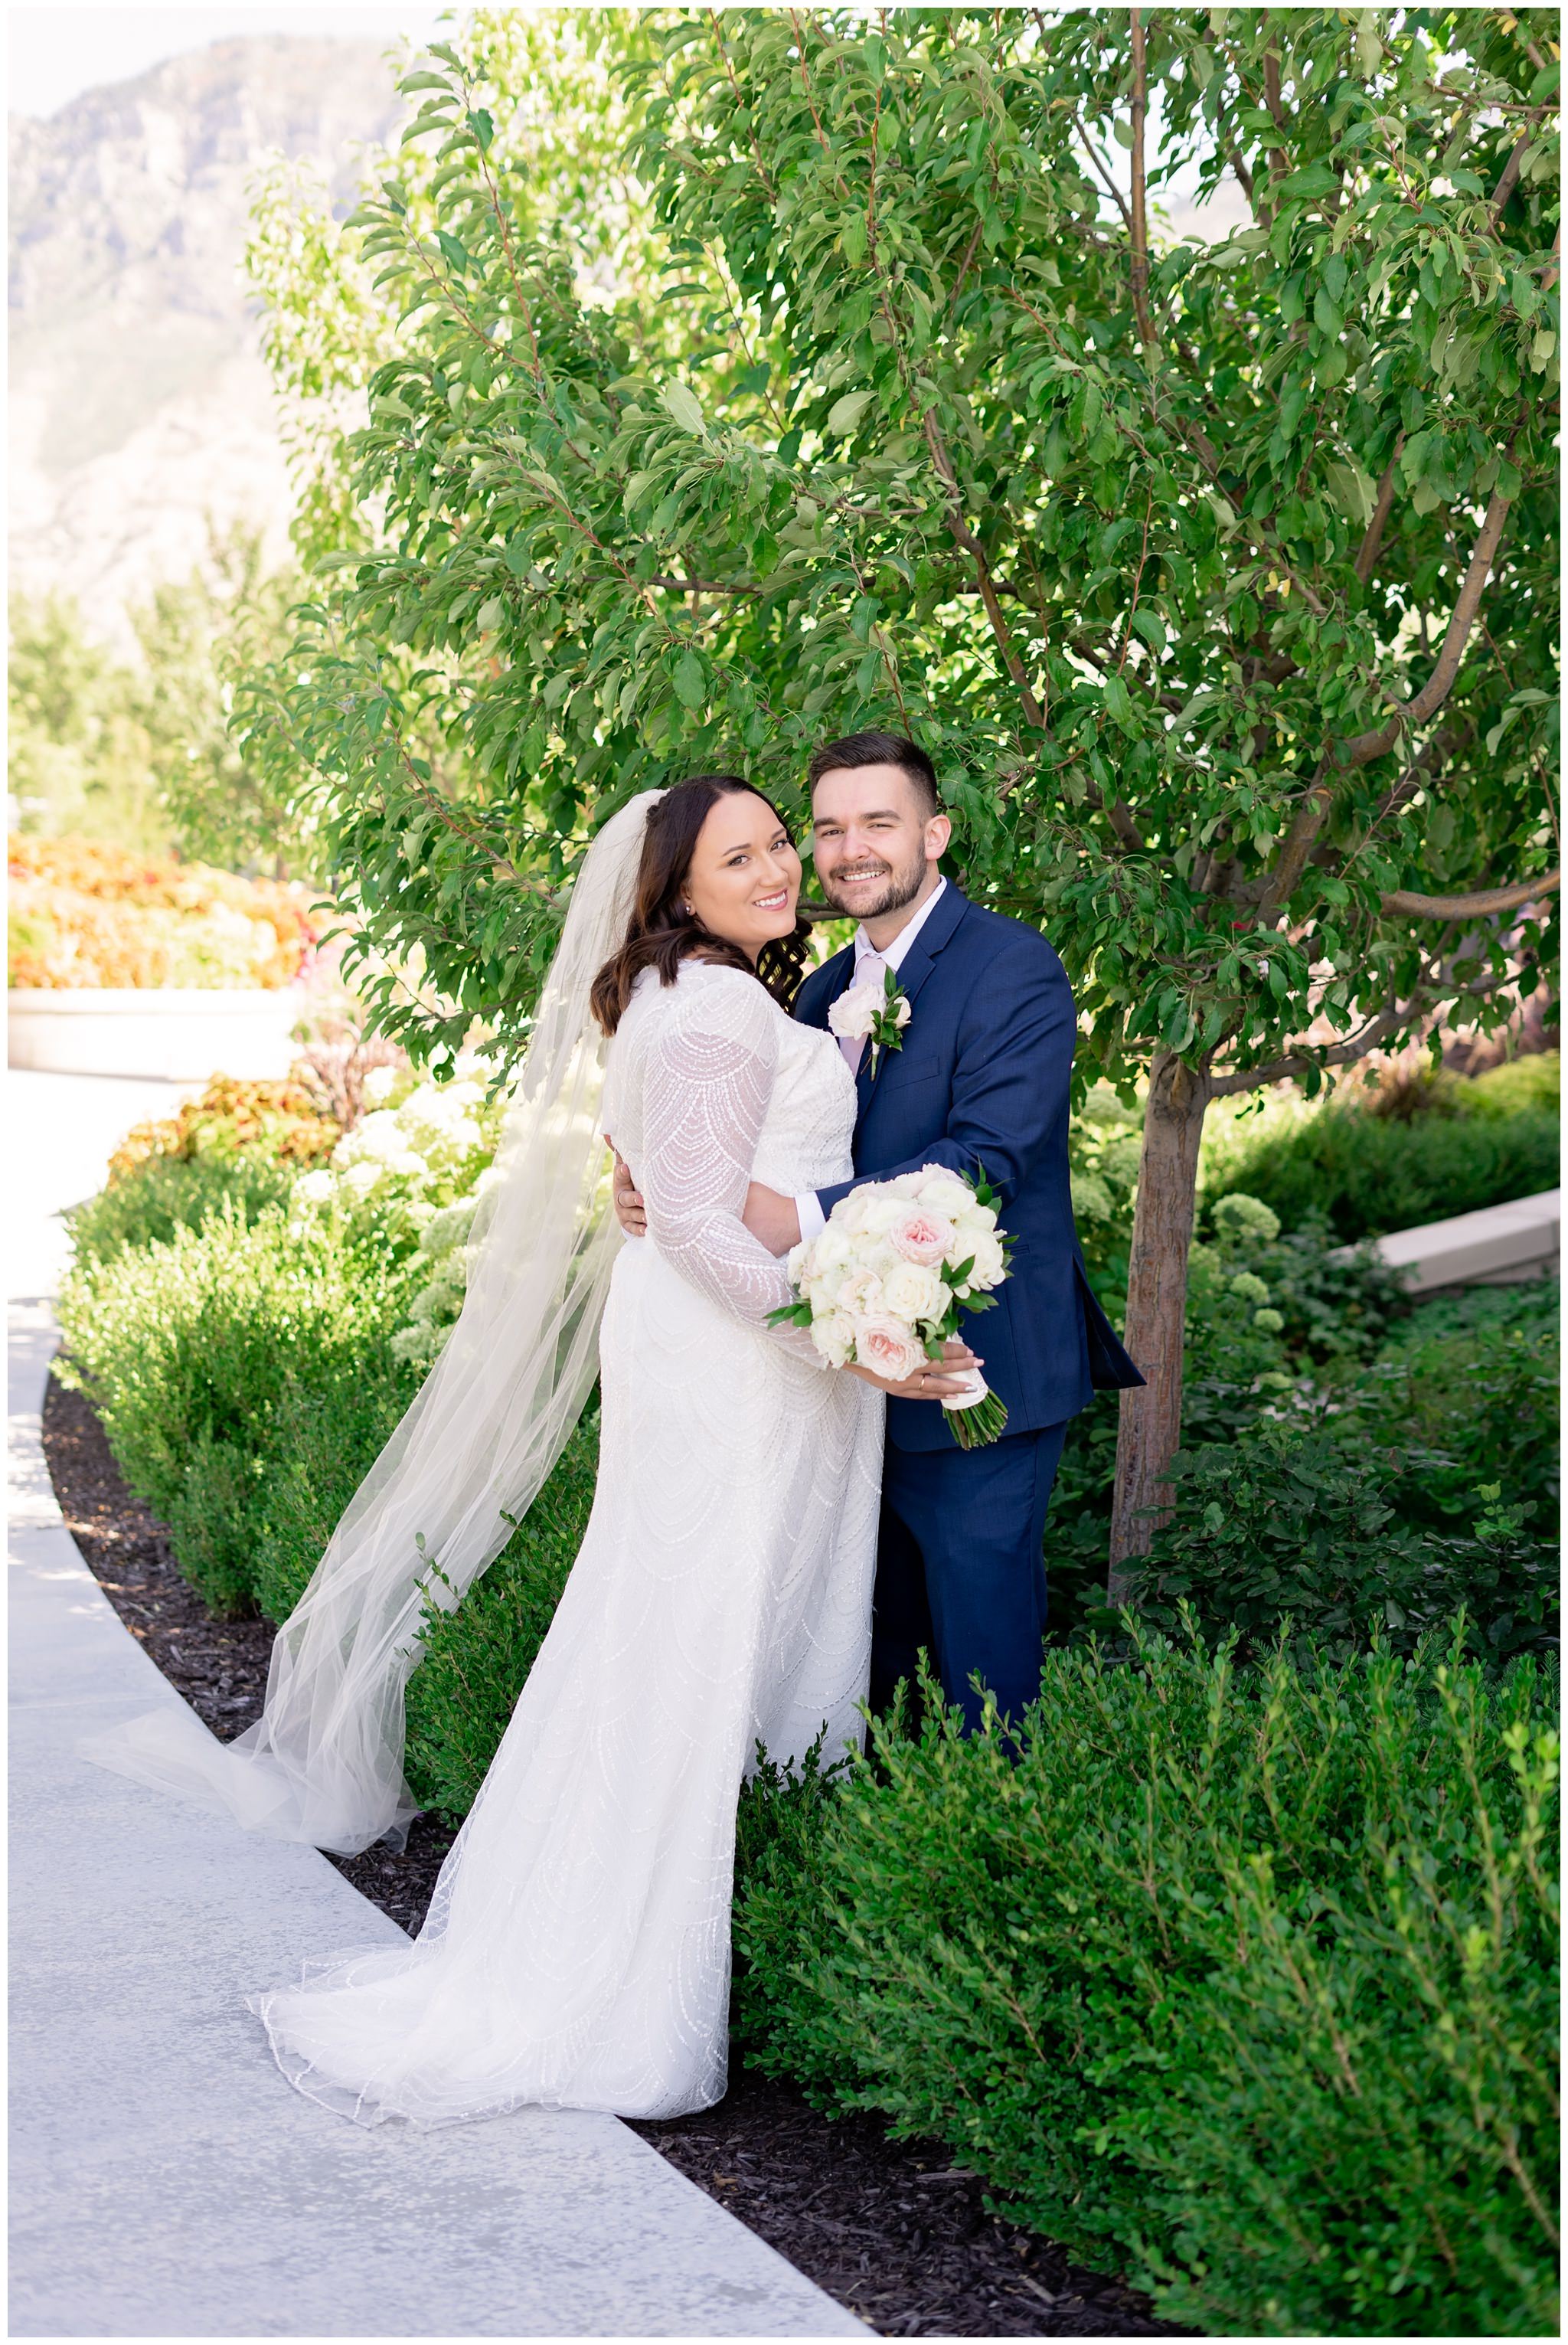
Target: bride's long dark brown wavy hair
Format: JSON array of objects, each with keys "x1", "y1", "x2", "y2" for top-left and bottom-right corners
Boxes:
[{"x1": 588, "y1": 773, "x2": 811, "y2": 1034}]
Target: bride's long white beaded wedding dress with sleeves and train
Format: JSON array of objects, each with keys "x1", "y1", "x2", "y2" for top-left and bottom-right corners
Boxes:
[{"x1": 253, "y1": 961, "x2": 884, "y2": 2124}]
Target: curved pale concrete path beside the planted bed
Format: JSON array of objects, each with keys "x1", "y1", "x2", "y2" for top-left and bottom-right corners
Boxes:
[{"x1": 9, "y1": 1074, "x2": 867, "y2": 2338}]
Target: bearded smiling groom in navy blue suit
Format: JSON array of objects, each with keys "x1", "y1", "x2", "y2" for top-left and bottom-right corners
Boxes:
[{"x1": 616, "y1": 731, "x2": 1144, "y2": 1726}]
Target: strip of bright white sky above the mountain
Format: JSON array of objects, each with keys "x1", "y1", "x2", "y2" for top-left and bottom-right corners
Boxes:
[{"x1": 5, "y1": 0, "x2": 462, "y2": 115}]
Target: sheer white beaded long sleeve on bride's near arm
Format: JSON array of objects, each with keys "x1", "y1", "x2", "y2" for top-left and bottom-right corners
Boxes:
[{"x1": 638, "y1": 969, "x2": 820, "y2": 1365}]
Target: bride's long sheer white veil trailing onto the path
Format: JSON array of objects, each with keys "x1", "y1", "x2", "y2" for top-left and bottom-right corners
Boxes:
[{"x1": 80, "y1": 790, "x2": 663, "y2": 1855}]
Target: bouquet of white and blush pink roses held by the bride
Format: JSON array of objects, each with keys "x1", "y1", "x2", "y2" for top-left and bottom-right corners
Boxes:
[{"x1": 771, "y1": 1166, "x2": 1012, "y2": 1449}]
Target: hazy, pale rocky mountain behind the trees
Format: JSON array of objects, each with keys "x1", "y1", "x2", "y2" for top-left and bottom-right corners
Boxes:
[{"x1": 9, "y1": 36, "x2": 403, "y2": 638}]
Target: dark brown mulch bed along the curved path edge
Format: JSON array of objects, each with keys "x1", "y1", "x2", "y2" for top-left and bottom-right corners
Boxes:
[{"x1": 44, "y1": 1379, "x2": 1188, "y2": 2338}]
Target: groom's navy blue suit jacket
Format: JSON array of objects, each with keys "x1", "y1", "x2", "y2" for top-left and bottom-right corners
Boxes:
[{"x1": 795, "y1": 881, "x2": 1144, "y2": 1449}]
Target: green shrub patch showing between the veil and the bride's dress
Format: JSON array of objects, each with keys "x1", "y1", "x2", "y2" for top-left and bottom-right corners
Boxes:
[{"x1": 403, "y1": 1402, "x2": 600, "y2": 1822}]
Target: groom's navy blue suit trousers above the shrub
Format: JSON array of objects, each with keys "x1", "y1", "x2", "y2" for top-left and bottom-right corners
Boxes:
[{"x1": 872, "y1": 1424, "x2": 1067, "y2": 1728}]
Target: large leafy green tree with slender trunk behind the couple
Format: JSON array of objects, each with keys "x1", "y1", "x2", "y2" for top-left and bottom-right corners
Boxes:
[{"x1": 251, "y1": 9, "x2": 1559, "y2": 1590}]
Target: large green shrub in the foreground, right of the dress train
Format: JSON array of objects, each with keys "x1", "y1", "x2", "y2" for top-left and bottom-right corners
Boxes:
[{"x1": 736, "y1": 1637, "x2": 1557, "y2": 2336}]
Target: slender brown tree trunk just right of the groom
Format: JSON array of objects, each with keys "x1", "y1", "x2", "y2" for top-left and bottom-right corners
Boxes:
[{"x1": 1106, "y1": 1051, "x2": 1210, "y2": 1604}]
